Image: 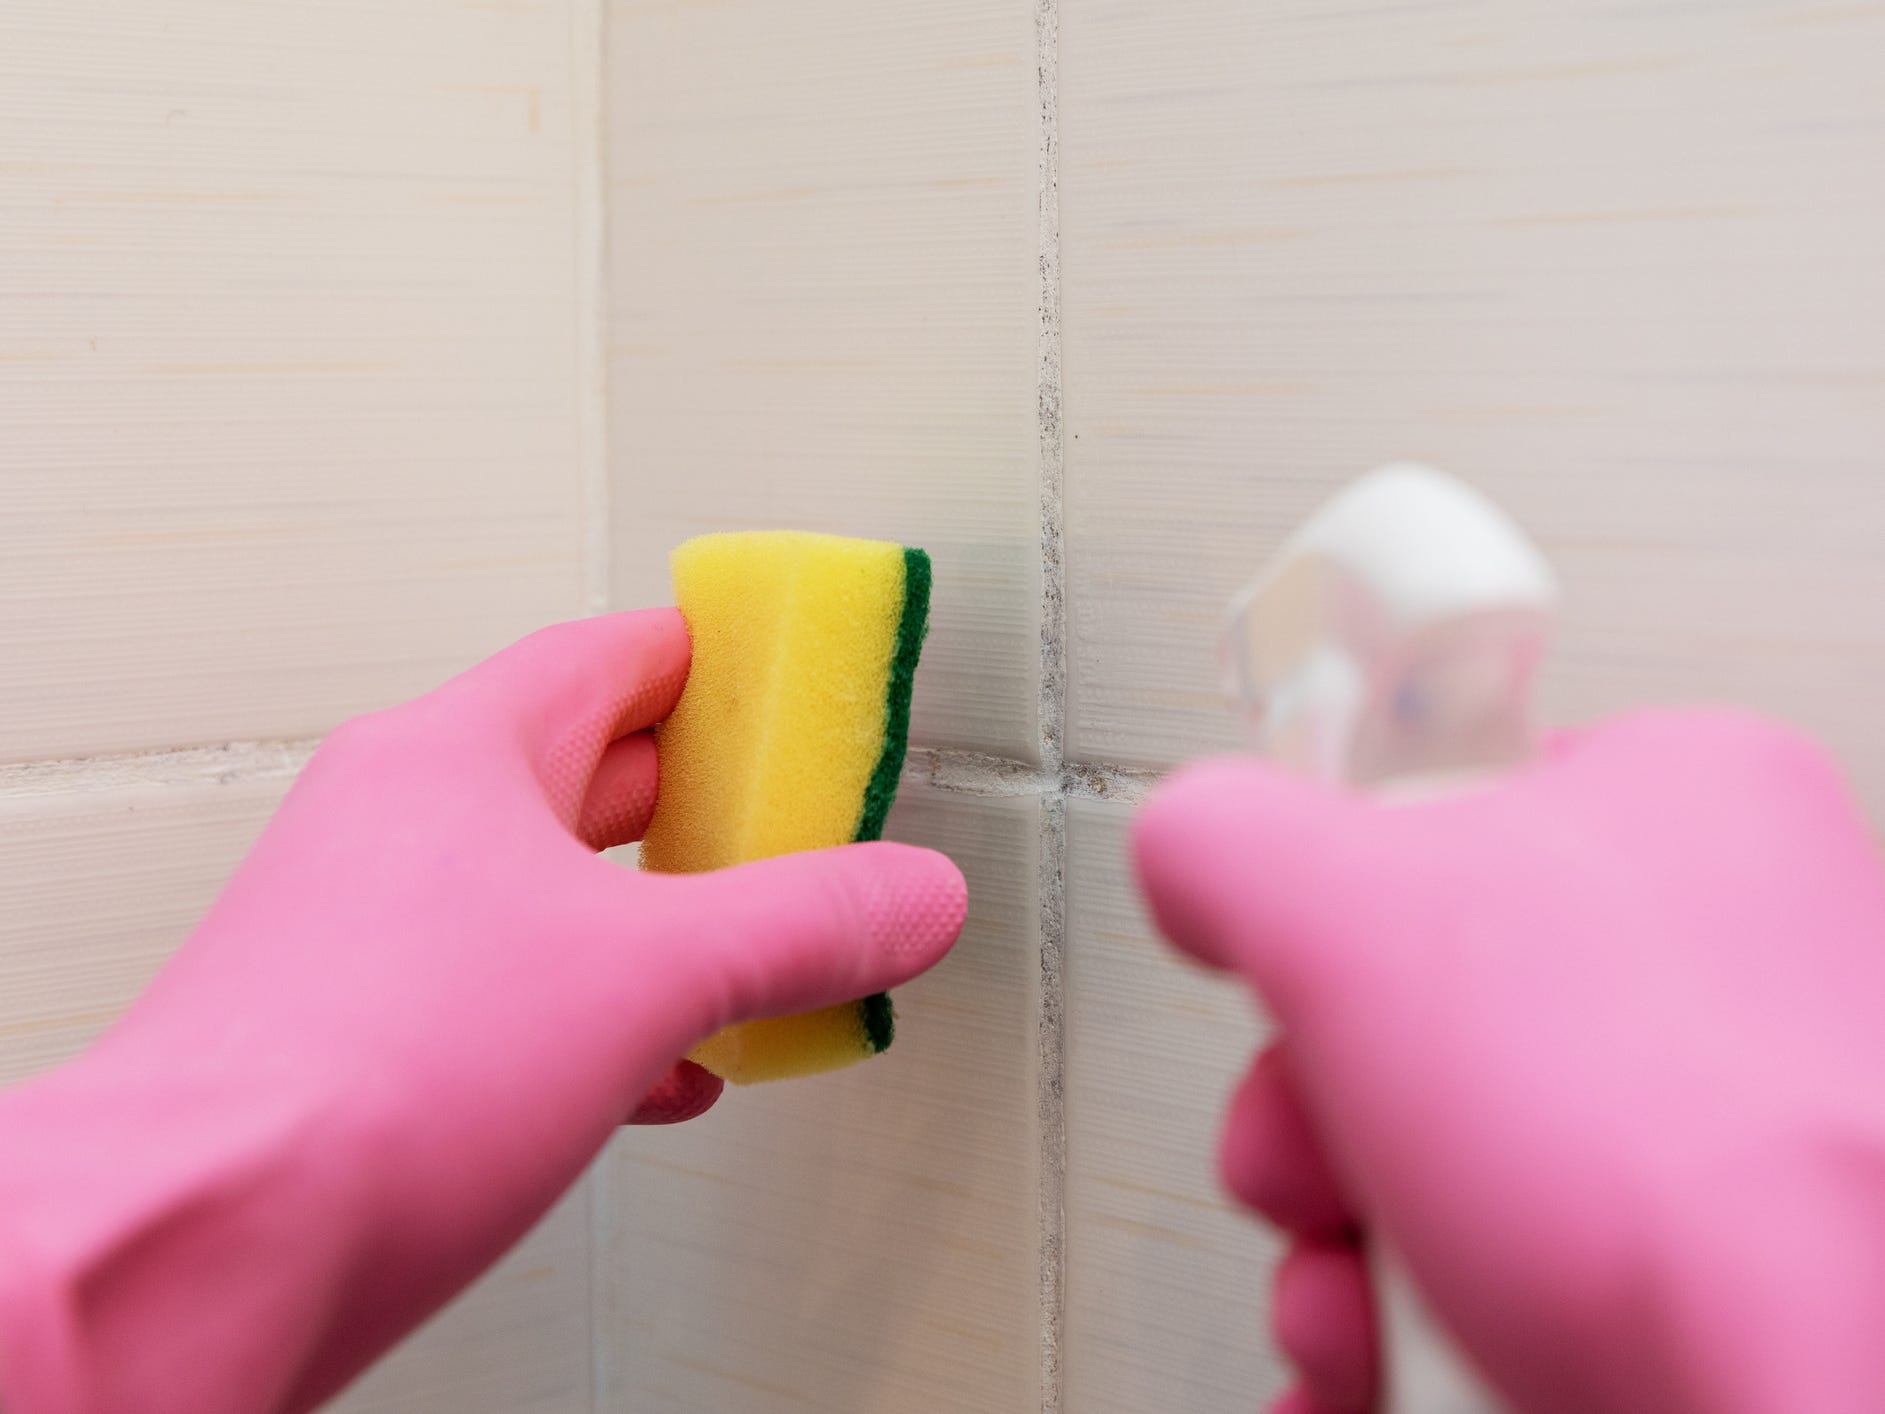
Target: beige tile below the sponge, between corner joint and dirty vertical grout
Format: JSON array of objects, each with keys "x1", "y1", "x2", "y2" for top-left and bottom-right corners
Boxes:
[{"x1": 596, "y1": 790, "x2": 1039, "y2": 1414}]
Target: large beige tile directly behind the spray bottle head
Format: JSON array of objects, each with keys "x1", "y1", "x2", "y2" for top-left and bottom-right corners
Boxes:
[{"x1": 1059, "y1": 0, "x2": 1885, "y2": 807}]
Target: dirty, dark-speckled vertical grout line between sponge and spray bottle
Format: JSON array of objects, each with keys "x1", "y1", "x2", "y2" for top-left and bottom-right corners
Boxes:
[{"x1": 1032, "y1": 0, "x2": 1067, "y2": 1414}]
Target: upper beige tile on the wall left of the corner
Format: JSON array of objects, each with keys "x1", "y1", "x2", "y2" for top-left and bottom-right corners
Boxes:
[{"x1": 0, "y1": 0, "x2": 582, "y2": 760}]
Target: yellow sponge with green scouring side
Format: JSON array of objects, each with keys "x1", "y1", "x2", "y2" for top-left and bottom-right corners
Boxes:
[{"x1": 641, "y1": 532, "x2": 929, "y2": 1084}]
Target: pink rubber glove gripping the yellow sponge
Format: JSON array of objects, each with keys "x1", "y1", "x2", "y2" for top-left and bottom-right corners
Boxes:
[{"x1": 0, "y1": 611, "x2": 965, "y2": 1414}]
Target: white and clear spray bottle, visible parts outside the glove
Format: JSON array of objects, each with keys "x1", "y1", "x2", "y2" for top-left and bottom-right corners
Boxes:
[{"x1": 1221, "y1": 464, "x2": 1559, "y2": 1414}]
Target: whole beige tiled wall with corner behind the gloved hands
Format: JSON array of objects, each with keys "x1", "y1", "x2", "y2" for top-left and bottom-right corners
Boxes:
[{"x1": 11, "y1": 0, "x2": 1885, "y2": 1414}]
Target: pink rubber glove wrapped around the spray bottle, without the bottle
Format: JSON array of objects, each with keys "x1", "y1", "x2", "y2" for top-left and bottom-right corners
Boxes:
[{"x1": 1135, "y1": 715, "x2": 1885, "y2": 1414}]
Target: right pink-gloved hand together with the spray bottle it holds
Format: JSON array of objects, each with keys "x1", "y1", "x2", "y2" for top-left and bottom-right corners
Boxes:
[{"x1": 1133, "y1": 468, "x2": 1885, "y2": 1414}]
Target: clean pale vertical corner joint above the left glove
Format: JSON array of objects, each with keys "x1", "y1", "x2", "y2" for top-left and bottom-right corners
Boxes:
[{"x1": 569, "y1": 0, "x2": 613, "y2": 615}]
